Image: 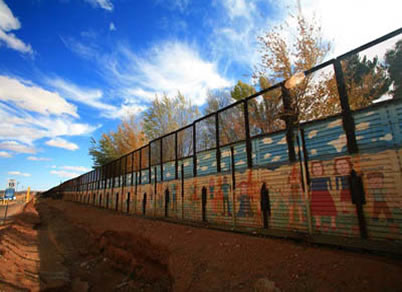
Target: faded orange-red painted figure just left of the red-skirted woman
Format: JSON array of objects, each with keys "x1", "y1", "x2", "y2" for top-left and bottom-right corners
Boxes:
[{"x1": 288, "y1": 164, "x2": 303, "y2": 224}]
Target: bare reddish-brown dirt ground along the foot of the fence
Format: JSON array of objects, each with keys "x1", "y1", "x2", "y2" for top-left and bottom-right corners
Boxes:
[{"x1": 0, "y1": 199, "x2": 402, "y2": 291}]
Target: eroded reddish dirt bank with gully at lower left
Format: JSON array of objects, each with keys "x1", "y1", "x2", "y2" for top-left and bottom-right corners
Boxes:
[{"x1": 0, "y1": 201, "x2": 171, "y2": 291}]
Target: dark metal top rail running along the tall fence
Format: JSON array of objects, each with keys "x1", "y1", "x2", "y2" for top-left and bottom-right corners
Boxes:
[{"x1": 54, "y1": 28, "x2": 402, "y2": 186}]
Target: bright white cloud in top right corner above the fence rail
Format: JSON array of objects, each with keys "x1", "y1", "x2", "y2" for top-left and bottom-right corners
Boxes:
[{"x1": 301, "y1": 0, "x2": 402, "y2": 56}]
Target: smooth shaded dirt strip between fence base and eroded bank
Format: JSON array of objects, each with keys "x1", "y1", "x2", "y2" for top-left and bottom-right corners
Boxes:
[{"x1": 41, "y1": 200, "x2": 402, "y2": 291}]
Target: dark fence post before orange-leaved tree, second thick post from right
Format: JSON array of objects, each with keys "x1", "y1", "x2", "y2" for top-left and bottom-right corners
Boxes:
[{"x1": 281, "y1": 83, "x2": 296, "y2": 162}]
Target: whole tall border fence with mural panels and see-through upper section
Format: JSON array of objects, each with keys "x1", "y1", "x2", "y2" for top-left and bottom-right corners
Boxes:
[{"x1": 44, "y1": 28, "x2": 402, "y2": 253}]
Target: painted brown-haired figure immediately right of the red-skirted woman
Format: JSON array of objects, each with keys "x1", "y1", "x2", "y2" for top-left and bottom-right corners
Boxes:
[{"x1": 334, "y1": 157, "x2": 352, "y2": 213}]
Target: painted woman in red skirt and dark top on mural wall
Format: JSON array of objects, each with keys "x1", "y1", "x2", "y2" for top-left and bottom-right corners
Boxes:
[{"x1": 310, "y1": 161, "x2": 337, "y2": 229}]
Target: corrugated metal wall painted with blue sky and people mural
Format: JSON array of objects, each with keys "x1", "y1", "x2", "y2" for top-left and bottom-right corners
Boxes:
[{"x1": 65, "y1": 102, "x2": 402, "y2": 240}]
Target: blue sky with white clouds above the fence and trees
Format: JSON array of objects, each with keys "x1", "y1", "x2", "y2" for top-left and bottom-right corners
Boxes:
[{"x1": 0, "y1": 0, "x2": 402, "y2": 190}]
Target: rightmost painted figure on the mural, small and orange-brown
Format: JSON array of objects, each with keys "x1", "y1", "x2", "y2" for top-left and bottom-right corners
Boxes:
[{"x1": 366, "y1": 172, "x2": 394, "y2": 223}]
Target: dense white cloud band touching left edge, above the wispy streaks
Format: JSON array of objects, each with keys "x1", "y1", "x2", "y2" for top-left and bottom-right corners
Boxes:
[{"x1": 0, "y1": 75, "x2": 78, "y2": 118}]
